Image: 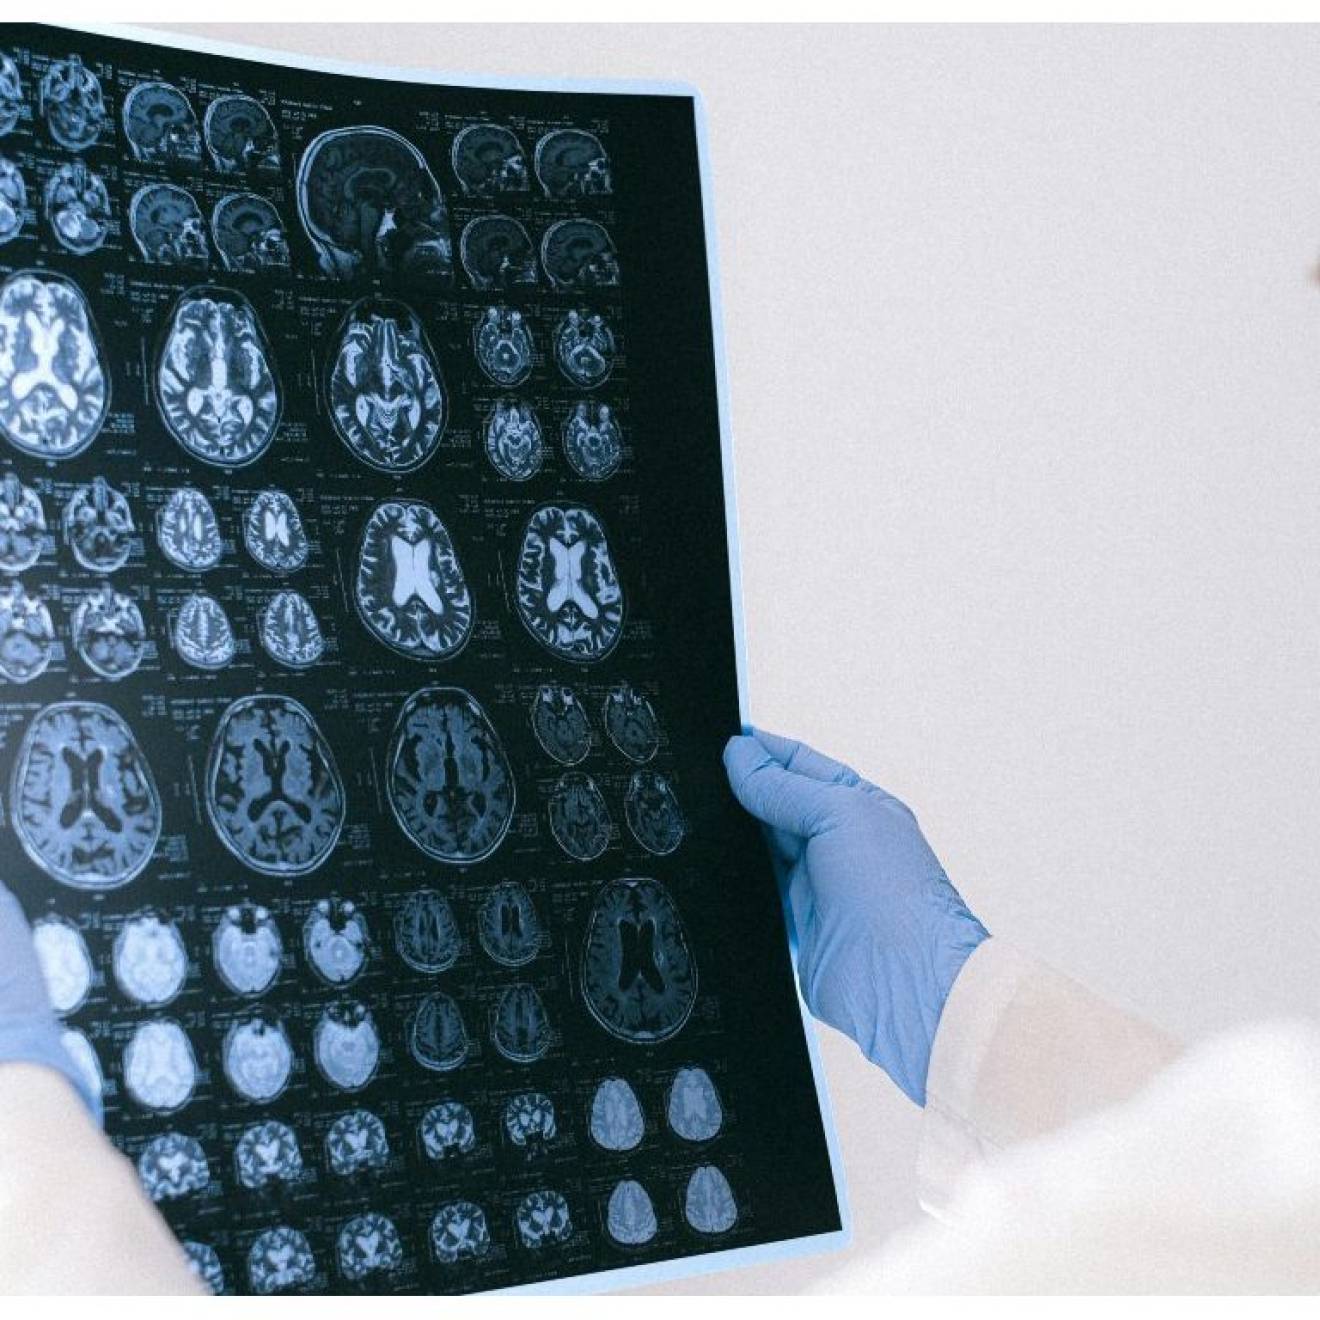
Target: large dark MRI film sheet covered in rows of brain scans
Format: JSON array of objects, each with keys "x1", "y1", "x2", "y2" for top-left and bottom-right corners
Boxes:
[{"x1": 0, "y1": 25, "x2": 842, "y2": 1294}]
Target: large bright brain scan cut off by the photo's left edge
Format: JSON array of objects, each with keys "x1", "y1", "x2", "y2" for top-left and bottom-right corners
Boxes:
[{"x1": 0, "y1": 271, "x2": 110, "y2": 458}]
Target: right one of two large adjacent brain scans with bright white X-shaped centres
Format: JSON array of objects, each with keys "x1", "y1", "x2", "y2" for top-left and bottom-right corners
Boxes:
[{"x1": 516, "y1": 504, "x2": 623, "y2": 664}]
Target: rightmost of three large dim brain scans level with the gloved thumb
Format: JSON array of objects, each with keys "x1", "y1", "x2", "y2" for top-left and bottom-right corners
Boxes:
[{"x1": 385, "y1": 688, "x2": 515, "y2": 863}]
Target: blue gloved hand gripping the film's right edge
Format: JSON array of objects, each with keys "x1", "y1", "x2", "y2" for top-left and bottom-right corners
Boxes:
[{"x1": 725, "y1": 730, "x2": 987, "y2": 1105}]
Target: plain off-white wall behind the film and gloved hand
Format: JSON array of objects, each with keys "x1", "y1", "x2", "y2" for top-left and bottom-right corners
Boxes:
[{"x1": 162, "y1": 25, "x2": 1320, "y2": 1292}]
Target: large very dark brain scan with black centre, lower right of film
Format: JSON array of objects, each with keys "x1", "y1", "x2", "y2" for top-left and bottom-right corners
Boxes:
[{"x1": 582, "y1": 878, "x2": 697, "y2": 1045}]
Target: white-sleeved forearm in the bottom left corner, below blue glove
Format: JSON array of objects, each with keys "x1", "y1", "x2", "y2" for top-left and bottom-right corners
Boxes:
[{"x1": 0, "y1": 1063, "x2": 205, "y2": 1294}]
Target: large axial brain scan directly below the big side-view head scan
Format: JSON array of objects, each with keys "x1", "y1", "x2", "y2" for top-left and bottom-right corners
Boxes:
[{"x1": 326, "y1": 298, "x2": 449, "y2": 473}]
